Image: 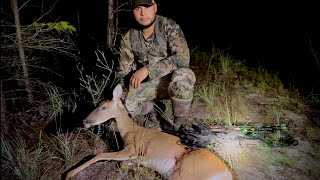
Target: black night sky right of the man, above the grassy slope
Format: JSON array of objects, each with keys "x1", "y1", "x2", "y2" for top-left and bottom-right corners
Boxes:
[{"x1": 154, "y1": 0, "x2": 320, "y2": 93}]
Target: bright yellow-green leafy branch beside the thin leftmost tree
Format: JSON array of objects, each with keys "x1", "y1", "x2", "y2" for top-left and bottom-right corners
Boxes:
[{"x1": 31, "y1": 21, "x2": 77, "y2": 34}]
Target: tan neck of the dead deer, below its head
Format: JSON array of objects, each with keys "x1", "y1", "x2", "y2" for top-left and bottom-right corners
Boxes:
[{"x1": 115, "y1": 109, "x2": 140, "y2": 137}]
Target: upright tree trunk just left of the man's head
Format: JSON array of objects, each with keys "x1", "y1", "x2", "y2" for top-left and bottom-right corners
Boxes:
[{"x1": 106, "y1": 0, "x2": 114, "y2": 48}]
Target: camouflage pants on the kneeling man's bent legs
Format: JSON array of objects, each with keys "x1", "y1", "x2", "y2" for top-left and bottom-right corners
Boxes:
[{"x1": 125, "y1": 68, "x2": 196, "y2": 116}]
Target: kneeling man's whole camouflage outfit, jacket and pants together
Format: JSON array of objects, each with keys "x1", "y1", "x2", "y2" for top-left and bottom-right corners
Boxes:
[{"x1": 118, "y1": 15, "x2": 196, "y2": 116}]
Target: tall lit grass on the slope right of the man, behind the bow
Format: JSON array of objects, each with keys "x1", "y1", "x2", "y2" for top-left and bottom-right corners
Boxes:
[{"x1": 192, "y1": 48, "x2": 305, "y2": 125}]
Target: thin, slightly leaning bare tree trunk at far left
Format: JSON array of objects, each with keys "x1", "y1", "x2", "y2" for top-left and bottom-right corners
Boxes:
[{"x1": 11, "y1": 0, "x2": 33, "y2": 102}]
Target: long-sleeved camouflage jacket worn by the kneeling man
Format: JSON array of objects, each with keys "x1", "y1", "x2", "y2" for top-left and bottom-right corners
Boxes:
[{"x1": 119, "y1": 15, "x2": 190, "y2": 80}]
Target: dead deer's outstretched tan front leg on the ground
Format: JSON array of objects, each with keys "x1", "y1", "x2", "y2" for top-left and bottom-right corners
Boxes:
[{"x1": 66, "y1": 145, "x2": 136, "y2": 180}]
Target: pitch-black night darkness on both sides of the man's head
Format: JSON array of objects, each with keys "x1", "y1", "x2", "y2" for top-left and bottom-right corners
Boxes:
[{"x1": 1, "y1": 0, "x2": 320, "y2": 94}]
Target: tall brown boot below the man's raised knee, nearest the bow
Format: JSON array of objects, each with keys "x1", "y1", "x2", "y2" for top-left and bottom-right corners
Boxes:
[{"x1": 171, "y1": 97, "x2": 192, "y2": 131}]
